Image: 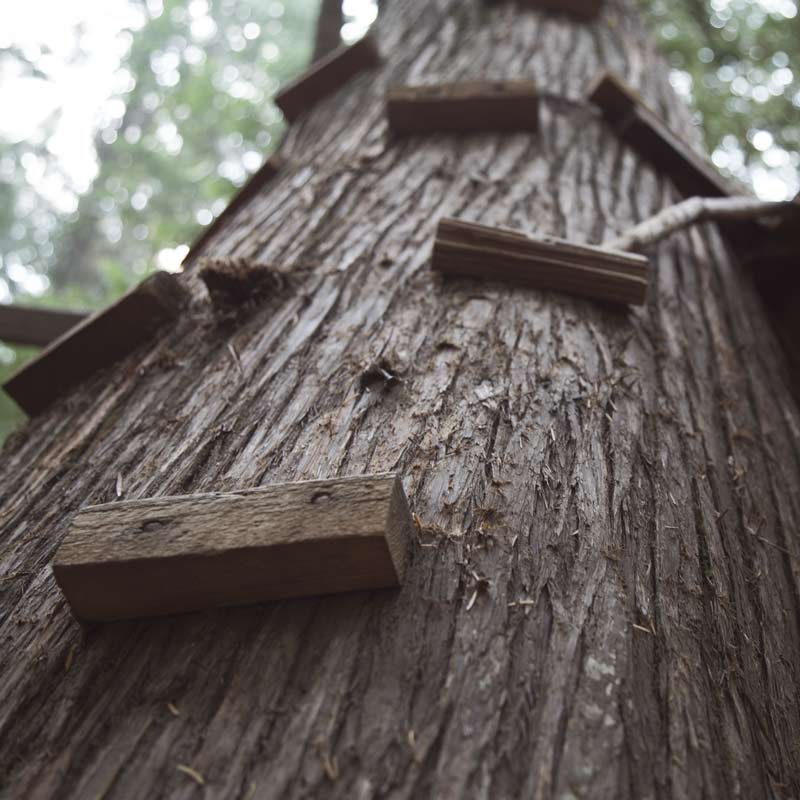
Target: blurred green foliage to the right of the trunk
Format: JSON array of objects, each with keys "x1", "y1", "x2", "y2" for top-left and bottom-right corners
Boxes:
[{"x1": 640, "y1": 0, "x2": 800, "y2": 200}]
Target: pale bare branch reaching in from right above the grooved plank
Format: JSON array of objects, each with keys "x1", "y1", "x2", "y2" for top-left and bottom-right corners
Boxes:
[{"x1": 603, "y1": 197, "x2": 800, "y2": 250}]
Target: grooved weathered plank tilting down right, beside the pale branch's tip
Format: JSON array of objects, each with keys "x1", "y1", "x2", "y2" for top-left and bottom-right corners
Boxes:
[{"x1": 432, "y1": 218, "x2": 650, "y2": 304}]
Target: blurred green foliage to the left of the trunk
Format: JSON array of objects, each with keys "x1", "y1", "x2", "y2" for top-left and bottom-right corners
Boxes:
[{"x1": 0, "y1": 0, "x2": 318, "y2": 305}]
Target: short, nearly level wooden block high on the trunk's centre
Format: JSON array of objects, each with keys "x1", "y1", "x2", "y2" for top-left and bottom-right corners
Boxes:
[{"x1": 386, "y1": 80, "x2": 539, "y2": 134}]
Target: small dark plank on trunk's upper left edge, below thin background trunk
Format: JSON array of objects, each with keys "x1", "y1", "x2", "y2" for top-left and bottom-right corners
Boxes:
[{"x1": 275, "y1": 34, "x2": 381, "y2": 122}]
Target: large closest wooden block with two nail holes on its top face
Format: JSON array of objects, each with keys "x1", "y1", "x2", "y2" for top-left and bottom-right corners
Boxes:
[{"x1": 53, "y1": 474, "x2": 412, "y2": 621}]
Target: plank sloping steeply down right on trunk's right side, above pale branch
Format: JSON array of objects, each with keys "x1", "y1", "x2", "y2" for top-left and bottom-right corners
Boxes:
[{"x1": 587, "y1": 72, "x2": 741, "y2": 197}]
